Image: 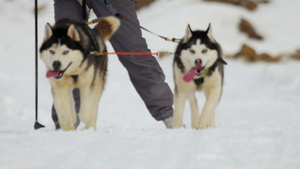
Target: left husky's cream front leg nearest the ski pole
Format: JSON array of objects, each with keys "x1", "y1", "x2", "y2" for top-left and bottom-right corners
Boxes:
[{"x1": 52, "y1": 87, "x2": 76, "y2": 130}]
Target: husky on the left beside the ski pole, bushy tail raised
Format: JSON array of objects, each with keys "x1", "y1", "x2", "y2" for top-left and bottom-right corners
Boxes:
[{"x1": 40, "y1": 17, "x2": 120, "y2": 130}]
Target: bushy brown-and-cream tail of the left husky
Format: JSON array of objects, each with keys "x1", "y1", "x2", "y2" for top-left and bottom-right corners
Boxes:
[{"x1": 94, "y1": 16, "x2": 121, "y2": 42}]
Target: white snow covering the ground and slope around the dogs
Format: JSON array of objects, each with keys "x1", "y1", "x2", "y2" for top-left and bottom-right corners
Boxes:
[{"x1": 0, "y1": 0, "x2": 300, "y2": 169}]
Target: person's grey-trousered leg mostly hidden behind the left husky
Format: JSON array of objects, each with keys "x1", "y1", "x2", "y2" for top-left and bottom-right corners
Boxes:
[{"x1": 52, "y1": 0, "x2": 82, "y2": 129}]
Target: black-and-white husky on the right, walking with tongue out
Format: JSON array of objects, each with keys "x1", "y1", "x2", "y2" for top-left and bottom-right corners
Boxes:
[{"x1": 173, "y1": 24, "x2": 227, "y2": 129}]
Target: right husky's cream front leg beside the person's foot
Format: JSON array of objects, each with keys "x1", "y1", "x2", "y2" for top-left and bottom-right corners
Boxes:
[{"x1": 173, "y1": 91, "x2": 187, "y2": 128}]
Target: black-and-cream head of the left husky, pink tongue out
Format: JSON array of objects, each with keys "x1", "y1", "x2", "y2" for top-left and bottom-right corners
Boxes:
[{"x1": 40, "y1": 23, "x2": 84, "y2": 79}]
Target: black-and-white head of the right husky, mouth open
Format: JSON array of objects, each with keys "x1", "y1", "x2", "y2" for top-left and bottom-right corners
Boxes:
[{"x1": 178, "y1": 24, "x2": 226, "y2": 76}]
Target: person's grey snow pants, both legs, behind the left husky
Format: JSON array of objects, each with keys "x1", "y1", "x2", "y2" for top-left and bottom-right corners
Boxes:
[{"x1": 52, "y1": 0, "x2": 173, "y2": 122}]
